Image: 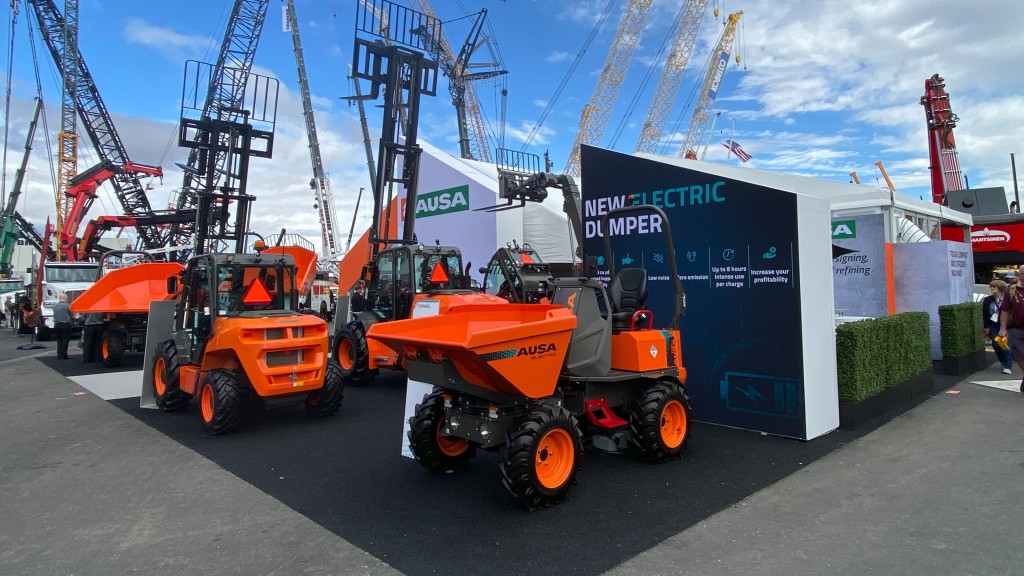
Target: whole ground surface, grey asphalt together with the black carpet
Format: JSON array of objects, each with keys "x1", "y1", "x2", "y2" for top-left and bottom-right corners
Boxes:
[{"x1": 0, "y1": 325, "x2": 1024, "y2": 575}]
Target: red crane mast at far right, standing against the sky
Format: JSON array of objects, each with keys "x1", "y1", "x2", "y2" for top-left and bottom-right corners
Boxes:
[{"x1": 921, "y1": 74, "x2": 964, "y2": 204}]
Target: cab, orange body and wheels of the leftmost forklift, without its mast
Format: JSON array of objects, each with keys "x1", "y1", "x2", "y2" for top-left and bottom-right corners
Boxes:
[{"x1": 153, "y1": 246, "x2": 344, "y2": 435}]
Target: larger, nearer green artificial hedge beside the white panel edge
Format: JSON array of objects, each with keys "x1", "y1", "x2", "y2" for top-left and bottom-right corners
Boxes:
[{"x1": 836, "y1": 310, "x2": 933, "y2": 402}]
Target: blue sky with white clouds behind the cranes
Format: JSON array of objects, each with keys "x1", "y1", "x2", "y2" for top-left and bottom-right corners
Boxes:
[{"x1": 3, "y1": 0, "x2": 1024, "y2": 245}]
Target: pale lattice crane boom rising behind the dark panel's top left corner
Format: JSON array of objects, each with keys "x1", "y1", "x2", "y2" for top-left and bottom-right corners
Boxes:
[{"x1": 562, "y1": 0, "x2": 652, "y2": 177}]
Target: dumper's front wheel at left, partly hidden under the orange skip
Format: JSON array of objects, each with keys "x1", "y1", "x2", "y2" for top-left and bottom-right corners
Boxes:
[{"x1": 409, "y1": 389, "x2": 476, "y2": 474}]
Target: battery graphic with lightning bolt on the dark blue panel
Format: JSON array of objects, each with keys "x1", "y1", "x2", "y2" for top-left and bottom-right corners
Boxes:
[{"x1": 719, "y1": 372, "x2": 801, "y2": 418}]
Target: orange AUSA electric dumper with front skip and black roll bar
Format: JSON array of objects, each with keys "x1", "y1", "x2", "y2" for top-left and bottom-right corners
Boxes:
[{"x1": 367, "y1": 206, "x2": 689, "y2": 509}]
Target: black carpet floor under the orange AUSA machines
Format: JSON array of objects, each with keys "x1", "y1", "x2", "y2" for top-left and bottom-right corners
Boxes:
[{"x1": 92, "y1": 366, "x2": 872, "y2": 576}]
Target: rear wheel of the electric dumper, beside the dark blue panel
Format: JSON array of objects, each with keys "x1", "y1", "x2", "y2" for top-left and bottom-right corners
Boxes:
[{"x1": 630, "y1": 380, "x2": 690, "y2": 462}]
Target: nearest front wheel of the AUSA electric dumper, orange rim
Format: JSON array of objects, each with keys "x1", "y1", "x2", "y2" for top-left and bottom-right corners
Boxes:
[{"x1": 501, "y1": 406, "x2": 583, "y2": 509}]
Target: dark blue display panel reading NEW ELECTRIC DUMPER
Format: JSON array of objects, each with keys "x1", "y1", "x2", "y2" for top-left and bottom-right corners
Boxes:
[{"x1": 581, "y1": 147, "x2": 802, "y2": 438}]
